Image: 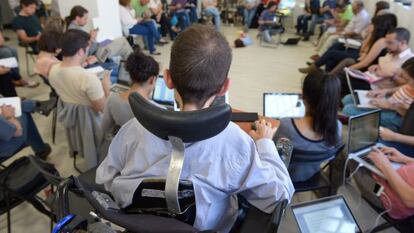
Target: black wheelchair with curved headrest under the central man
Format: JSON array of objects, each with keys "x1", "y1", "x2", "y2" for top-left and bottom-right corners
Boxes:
[{"x1": 45, "y1": 93, "x2": 292, "y2": 233}]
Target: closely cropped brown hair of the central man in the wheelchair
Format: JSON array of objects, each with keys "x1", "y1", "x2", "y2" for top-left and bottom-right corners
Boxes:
[{"x1": 170, "y1": 25, "x2": 232, "y2": 107}]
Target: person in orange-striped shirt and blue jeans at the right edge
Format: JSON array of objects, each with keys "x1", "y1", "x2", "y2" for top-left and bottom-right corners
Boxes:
[{"x1": 342, "y1": 57, "x2": 414, "y2": 130}]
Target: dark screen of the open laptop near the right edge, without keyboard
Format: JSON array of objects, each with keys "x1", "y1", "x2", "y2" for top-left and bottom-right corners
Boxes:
[{"x1": 348, "y1": 110, "x2": 381, "y2": 153}]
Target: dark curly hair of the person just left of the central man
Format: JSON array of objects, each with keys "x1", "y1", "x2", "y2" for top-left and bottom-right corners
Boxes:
[{"x1": 125, "y1": 50, "x2": 160, "y2": 83}]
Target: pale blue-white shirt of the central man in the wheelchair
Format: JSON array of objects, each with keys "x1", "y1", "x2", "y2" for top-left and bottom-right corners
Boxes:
[{"x1": 96, "y1": 118, "x2": 294, "y2": 232}]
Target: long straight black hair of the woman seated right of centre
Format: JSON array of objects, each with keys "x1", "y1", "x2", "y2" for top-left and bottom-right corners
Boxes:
[{"x1": 302, "y1": 71, "x2": 341, "y2": 146}]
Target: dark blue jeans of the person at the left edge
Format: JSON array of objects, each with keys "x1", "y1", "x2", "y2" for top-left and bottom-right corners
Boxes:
[{"x1": 0, "y1": 100, "x2": 46, "y2": 157}]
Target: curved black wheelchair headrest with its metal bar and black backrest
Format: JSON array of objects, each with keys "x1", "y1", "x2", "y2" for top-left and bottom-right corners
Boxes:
[{"x1": 126, "y1": 93, "x2": 231, "y2": 224}]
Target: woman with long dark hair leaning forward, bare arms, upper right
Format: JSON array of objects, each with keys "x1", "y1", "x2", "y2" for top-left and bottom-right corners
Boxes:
[{"x1": 330, "y1": 13, "x2": 397, "y2": 75}]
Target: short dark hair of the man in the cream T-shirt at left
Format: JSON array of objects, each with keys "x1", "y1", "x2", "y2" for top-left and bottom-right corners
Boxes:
[{"x1": 62, "y1": 29, "x2": 90, "y2": 57}]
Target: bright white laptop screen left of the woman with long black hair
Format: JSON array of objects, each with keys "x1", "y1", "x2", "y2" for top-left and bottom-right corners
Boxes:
[{"x1": 263, "y1": 92, "x2": 305, "y2": 119}]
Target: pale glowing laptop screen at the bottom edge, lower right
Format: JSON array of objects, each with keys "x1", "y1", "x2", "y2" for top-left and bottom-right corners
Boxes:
[{"x1": 291, "y1": 195, "x2": 362, "y2": 233}]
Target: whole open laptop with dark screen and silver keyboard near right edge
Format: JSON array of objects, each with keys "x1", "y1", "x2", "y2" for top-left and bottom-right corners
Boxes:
[{"x1": 348, "y1": 109, "x2": 401, "y2": 178}]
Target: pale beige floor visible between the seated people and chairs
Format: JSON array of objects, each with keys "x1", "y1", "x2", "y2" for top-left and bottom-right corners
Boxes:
[{"x1": 0, "y1": 27, "x2": 398, "y2": 233}]
